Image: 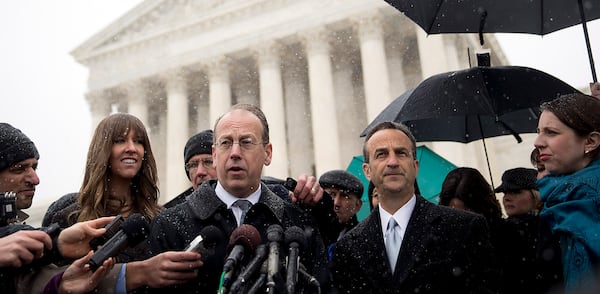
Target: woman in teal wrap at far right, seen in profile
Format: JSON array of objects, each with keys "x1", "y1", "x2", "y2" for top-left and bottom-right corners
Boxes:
[{"x1": 534, "y1": 94, "x2": 600, "y2": 293}]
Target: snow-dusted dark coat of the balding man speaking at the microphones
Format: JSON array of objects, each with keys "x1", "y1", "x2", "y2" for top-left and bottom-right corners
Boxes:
[{"x1": 148, "y1": 180, "x2": 328, "y2": 293}]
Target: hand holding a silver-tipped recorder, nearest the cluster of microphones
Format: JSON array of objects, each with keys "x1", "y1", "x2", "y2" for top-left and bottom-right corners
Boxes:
[{"x1": 125, "y1": 251, "x2": 203, "y2": 291}]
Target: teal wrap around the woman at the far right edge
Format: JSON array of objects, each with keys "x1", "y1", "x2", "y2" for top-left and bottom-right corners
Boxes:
[{"x1": 537, "y1": 159, "x2": 600, "y2": 293}]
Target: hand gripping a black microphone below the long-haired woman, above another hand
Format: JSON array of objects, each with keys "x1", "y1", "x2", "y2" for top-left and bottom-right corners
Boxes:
[{"x1": 58, "y1": 216, "x2": 114, "y2": 258}]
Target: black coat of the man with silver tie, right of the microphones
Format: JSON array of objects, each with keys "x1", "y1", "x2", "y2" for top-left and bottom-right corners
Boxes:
[{"x1": 333, "y1": 196, "x2": 498, "y2": 293}]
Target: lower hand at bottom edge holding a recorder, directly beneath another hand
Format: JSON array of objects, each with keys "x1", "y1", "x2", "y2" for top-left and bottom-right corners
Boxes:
[{"x1": 58, "y1": 251, "x2": 115, "y2": 293}]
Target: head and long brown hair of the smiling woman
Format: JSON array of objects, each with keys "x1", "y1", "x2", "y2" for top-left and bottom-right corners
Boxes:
[{"x1": 72, "y1": 113, "x2": 160, "y2": 221}]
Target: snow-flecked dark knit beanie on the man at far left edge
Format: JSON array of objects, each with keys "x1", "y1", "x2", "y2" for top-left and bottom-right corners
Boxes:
[{"x1": 0, "y1": 123, "x2": 40, "y2": 171}]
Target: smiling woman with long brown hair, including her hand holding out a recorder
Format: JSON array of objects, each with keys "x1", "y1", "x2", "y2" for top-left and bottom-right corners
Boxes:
[{"x1": 45, "y1": 113, "x2": 201, "y2": 291}]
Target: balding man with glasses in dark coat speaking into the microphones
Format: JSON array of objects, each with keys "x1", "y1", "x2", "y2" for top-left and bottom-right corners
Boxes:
[{"x1": 149, "y1": 104, "x2": 328, "y2": 293}]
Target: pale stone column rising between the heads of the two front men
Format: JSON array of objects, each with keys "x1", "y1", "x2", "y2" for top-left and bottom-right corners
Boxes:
[{"x1": 304, "y1": 30, "x2": 341, "y2": 176}]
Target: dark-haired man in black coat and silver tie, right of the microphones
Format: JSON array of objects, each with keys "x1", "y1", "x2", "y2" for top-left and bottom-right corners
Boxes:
[{"x1": 333, "y1": 122, "x2": 498, "y2": 293}]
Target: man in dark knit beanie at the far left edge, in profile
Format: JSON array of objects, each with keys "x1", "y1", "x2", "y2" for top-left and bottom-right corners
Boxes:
[{"x1": 0, "y1": 123, "x2": 40, "y2": 221}]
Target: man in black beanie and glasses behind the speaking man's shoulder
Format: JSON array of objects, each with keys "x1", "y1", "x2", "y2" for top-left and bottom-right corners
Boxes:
[{"x1": 164, "y1": 130, "x2": 217, "y2": 208}]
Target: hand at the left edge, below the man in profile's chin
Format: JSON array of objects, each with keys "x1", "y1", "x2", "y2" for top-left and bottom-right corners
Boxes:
[{"x1": 0, "y1": 230, "x2": 52, "y2": 268}]
